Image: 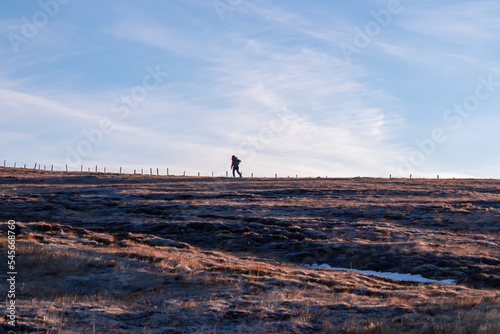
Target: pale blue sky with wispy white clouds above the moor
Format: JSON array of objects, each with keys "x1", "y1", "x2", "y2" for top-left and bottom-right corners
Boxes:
[{"x1": 0, "y1": 0, "x2": 500, "y2": 178}]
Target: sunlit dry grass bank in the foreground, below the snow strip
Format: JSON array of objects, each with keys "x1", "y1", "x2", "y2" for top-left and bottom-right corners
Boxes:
[{"x1": 2, "y1": 230, "x2": 500, "y2": 334}]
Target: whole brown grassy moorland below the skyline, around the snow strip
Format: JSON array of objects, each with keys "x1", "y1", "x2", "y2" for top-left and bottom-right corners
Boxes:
[{"x1": 0, "y1": 168, "x2": 500, "y2": 333}]
